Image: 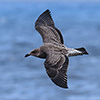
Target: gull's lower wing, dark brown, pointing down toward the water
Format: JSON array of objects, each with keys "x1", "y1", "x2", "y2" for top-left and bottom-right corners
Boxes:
[{"x1": 44, "y1": 54, "x2": 69, "y2": 88}]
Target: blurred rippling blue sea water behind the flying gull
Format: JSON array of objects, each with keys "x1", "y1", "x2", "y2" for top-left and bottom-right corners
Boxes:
[{"x1": 0, "y1": 1, "x2": 100, "y2": 100}]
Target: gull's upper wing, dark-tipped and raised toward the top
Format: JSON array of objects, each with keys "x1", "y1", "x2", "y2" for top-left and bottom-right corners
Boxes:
[{"x1": 35, "y1": 10, "x2": 64, "y2": 44}]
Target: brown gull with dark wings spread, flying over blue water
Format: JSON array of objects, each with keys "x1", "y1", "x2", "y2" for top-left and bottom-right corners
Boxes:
[{"x1": 25, "y1": 9, "x2": 88, "y2": 89}]
